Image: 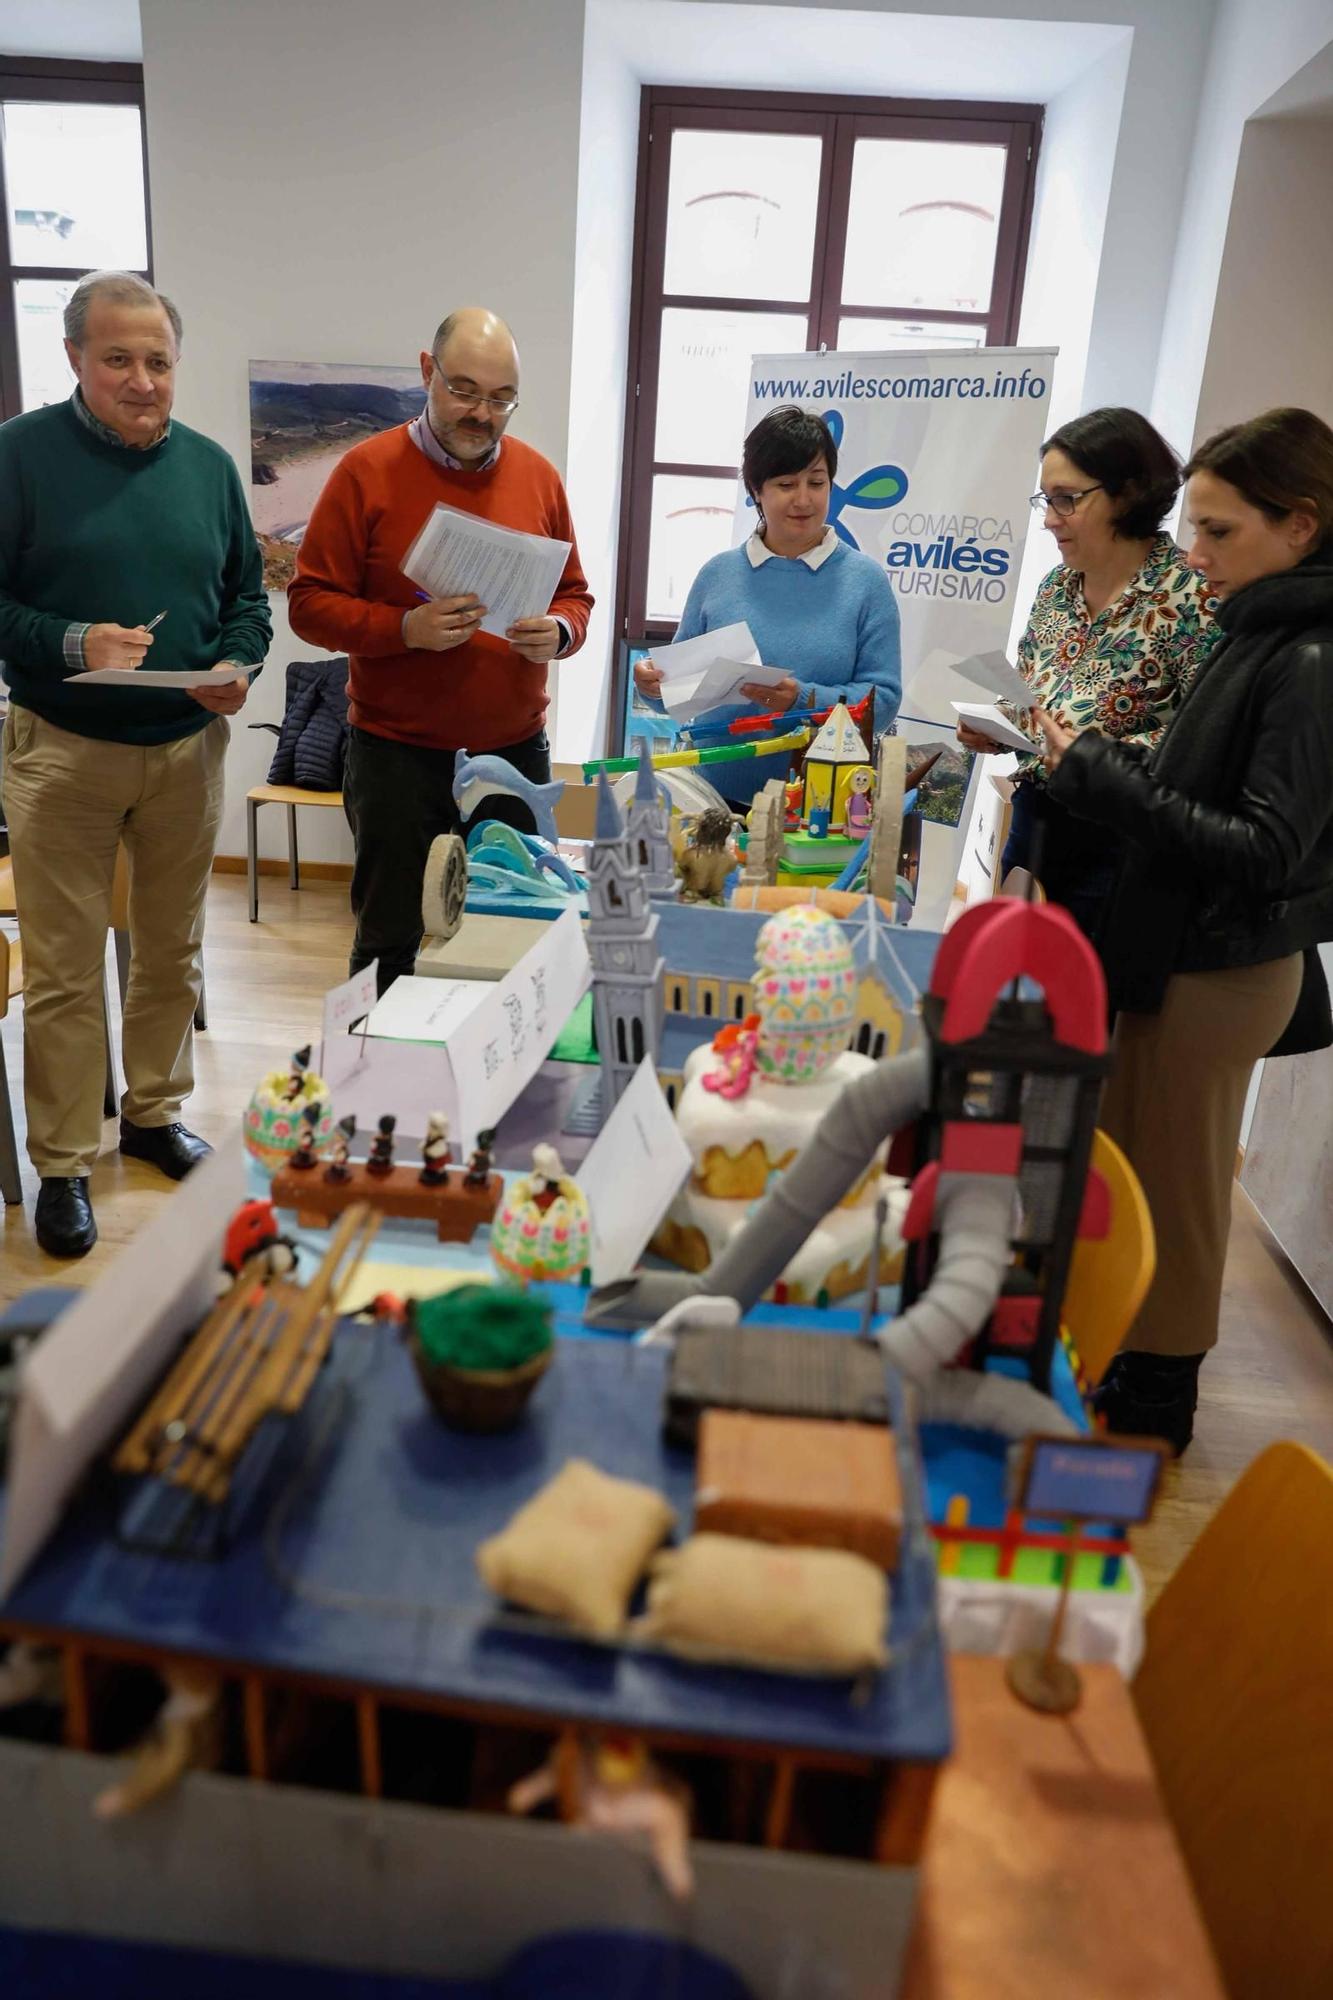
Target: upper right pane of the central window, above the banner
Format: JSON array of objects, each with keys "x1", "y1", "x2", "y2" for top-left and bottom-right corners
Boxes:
[{"x1": 843, "y1": 138, "x2": 1005, "y2": 312}]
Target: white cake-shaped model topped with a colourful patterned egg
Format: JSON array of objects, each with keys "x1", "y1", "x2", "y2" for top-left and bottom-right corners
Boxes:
[{"x1": 652, "y1": 906, "x2": 908, "y2": 1304}]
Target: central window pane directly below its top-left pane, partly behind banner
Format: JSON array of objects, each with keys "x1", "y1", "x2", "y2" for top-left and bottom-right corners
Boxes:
[{"x1": 652, "y1": 306, "x2": 807, "y2": 466}]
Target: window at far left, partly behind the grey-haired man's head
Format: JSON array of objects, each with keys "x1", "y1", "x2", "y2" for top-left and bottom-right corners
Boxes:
[{"x1": 0, "y1": 56, "x2": 152, "y2": 418}]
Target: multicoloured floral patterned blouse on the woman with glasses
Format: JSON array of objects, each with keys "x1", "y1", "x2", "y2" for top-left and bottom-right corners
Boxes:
[{"x1": 1013, "y1": 534, "x2": 1221, "y2": 784}]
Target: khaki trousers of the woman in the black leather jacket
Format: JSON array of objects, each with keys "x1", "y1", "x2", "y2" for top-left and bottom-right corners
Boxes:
[{"x1": 1101, "y1": 954, "x2": 1301, "y2": 1354}]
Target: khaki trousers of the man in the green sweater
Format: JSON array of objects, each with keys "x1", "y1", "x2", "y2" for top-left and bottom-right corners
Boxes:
[{"x1": 4, "y1": 706, "x2": 230, "y2": 1178}]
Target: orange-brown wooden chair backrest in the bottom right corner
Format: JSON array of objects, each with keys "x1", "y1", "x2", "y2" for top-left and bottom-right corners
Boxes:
[{"x1": 1133, "y1": 1444, "x2": 1333, "y2": 2000}]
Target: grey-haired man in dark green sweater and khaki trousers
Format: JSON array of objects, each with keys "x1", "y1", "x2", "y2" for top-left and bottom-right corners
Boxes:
[{"x1": 0, "y1": 272, "x2": 272, "y2": 1256}]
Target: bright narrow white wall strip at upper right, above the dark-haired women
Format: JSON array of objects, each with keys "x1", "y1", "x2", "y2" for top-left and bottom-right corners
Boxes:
[{"x1": 1151, "y1": 0, "x2": 1333, "y2": 442}]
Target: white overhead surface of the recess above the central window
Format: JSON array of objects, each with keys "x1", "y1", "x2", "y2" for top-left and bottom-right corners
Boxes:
[{"x1": 588, "y1": 0, "x2": 1131, "y2": 104}]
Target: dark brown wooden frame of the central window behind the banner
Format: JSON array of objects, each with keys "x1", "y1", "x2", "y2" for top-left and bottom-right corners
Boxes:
[{"x1": 608, "y1": 84, "x2": 1043, "y2": 744}]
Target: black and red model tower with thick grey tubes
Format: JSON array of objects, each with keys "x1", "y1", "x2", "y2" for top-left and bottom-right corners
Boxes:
[{"x1": 588, "y1": 898, "x2": 1109, "y2": 1436}]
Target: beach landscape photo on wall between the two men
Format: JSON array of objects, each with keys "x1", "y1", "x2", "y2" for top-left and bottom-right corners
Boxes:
[{"x1": 250, "y1": 362, "x2": 426, "y2": 590}]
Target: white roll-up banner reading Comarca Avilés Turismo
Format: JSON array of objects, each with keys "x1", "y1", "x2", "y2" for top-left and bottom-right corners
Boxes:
[{"x1": 735, "y1": 348, "x2": 1057, "y2": 930}]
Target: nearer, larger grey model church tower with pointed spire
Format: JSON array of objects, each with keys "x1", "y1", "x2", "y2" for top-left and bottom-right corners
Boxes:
[{"x1": 586, "y1": 772, "x2": 664, "y2": 1118}]
